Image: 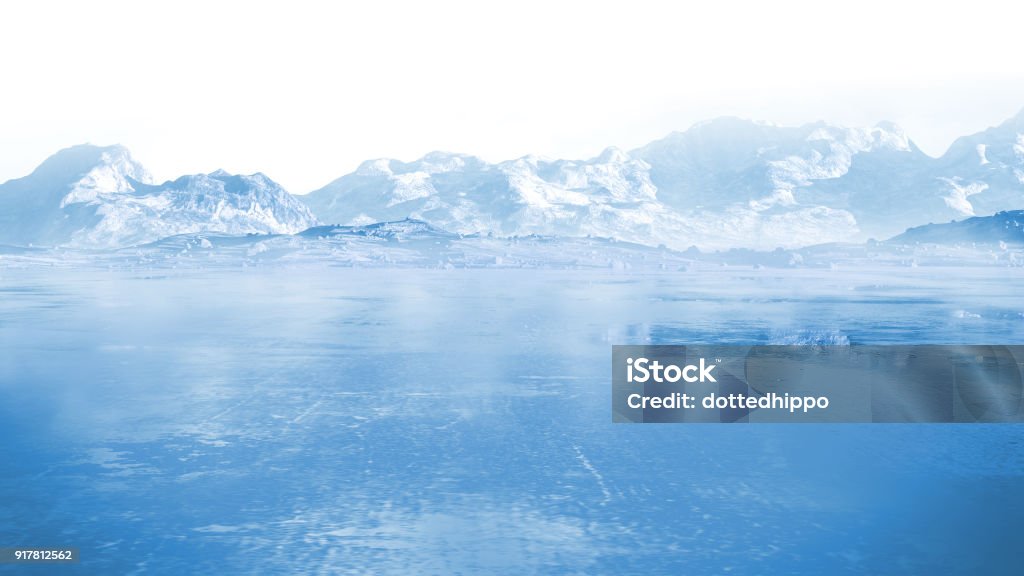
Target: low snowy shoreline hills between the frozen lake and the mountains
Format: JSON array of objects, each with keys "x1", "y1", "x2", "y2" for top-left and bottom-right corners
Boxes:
[{"x1": 0, "y1": 214, "x2": 1024, "y2": 272}]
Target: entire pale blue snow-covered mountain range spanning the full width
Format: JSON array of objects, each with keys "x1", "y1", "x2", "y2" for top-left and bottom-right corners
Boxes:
[{"x1": 0, "y1": 112, "x2": 1024, "y2": 249}]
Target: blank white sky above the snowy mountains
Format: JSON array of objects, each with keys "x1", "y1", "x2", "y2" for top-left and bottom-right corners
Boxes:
[{"x1": 0, "y1": 0, "x2": 1024, "y2": 194}]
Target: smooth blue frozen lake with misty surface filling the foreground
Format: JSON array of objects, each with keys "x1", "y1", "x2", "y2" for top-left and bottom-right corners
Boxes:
[{"x1": 0, "y1": 261, "x2": 1024, "y2": 574}]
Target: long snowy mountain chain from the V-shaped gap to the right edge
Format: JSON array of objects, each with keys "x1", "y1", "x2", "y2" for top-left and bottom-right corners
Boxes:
[{"x1": 303, "y1": 113, "x2": 1024, "y2": 249}]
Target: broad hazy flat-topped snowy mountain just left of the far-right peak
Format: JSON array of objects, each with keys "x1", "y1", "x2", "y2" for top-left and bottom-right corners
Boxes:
[{"x1": 634, "y1": 118, "x2": 952, "y2": 239}]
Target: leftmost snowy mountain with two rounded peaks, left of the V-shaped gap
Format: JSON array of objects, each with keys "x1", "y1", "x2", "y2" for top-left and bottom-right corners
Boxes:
[{"x1": 0, "y1": 145, "x2": 316, "y2": 247}]
